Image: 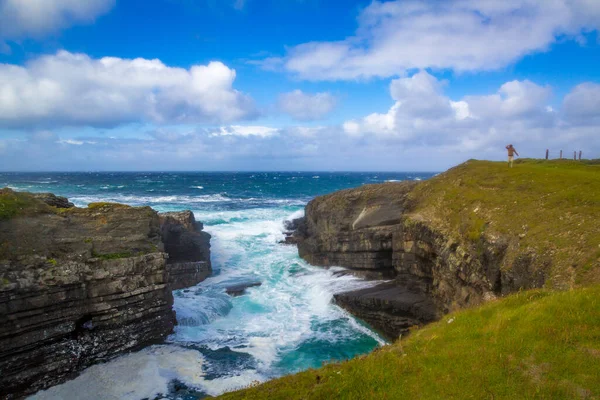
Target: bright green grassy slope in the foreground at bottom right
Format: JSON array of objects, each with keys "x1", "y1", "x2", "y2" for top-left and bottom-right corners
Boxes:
[{"x1": 221, "y1": 285, "x2": 600, "y2": 399}]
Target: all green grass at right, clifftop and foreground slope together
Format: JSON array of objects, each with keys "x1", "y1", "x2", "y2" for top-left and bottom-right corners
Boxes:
[{"x1": 222, "y1": 159, "x2": 600, "y2": 399}]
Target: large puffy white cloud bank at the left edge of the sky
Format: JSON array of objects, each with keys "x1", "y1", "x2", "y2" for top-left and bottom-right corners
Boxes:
[{"x1": 0, "y1": 51, "x2": 257, "y2": 128}]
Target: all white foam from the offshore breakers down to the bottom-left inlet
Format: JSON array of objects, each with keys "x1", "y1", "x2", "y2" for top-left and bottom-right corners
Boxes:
[{"x1": 29, "y1": 189, "x2": 385, "y2": 399}]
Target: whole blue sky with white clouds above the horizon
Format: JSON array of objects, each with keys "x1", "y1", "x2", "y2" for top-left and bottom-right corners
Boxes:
[{"x1": 0, "y1": 0, "x2": 600, "y2": 171}]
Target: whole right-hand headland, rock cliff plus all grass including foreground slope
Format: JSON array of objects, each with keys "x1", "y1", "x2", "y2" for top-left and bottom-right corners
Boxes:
[{"x1": 220, "y1": 160, "x2": 600, "y2": 399}]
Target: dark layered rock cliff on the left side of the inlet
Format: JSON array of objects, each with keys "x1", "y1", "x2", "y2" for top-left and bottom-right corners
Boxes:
[{"x1": 0, "y1": 189, "x2": 210, "y2": 398}]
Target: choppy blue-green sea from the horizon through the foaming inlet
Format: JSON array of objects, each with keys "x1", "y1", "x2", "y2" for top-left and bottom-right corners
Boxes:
[{"x1": 0, "y1": 172, "x2": 433, "y2": 400}]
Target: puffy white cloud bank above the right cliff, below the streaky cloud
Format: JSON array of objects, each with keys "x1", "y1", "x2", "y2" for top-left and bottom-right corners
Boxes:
[{"x1": 343, "y1": 71, "x2": 563, "y2": 151}]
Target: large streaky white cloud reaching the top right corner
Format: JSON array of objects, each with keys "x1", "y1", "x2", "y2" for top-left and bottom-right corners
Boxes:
[{"x1": 265, "y1": 0, "x2": 600, "y2": 80}]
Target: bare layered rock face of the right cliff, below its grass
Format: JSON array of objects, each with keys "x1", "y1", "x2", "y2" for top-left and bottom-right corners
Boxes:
[{"x1": 298, "y1": 182, "x2": 545, "y2": 338}]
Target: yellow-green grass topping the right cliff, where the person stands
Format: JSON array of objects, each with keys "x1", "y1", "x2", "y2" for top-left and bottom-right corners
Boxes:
[{"x1": 411, "y1": 159, "x2": 600, "y2": 288}]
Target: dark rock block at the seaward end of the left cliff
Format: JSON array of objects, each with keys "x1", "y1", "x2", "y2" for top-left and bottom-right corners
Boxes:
[{"x1": 159, "y1": 210, "x2": 212, "y2": 290}]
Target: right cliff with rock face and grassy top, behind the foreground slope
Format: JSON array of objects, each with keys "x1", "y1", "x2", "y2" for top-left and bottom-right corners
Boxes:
[{"x1": 298, "y1": 160, "x2": 600, "y2": 337}]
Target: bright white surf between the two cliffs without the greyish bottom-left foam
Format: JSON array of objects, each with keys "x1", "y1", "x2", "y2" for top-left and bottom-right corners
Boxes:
[{"x1": 169, "y1": 203, "x2": 385, "y2": 394}]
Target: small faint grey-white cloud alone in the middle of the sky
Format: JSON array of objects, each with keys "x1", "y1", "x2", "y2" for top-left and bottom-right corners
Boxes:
[{"x1": 278, "y1": 90, "x2": 337, "y2": 121}]
